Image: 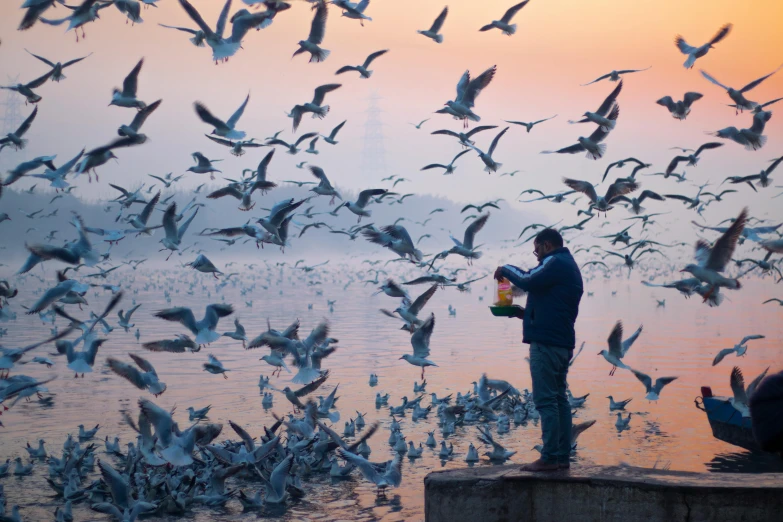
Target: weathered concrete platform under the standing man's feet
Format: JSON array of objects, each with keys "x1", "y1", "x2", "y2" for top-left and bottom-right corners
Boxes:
[{"x1": 424, "y1": 464, "x2": 783, "y2": 522}]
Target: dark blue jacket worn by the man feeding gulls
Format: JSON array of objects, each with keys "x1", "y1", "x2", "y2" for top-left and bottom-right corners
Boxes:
[{"x1": 501, "y1": 247, "x2": 583, "y2": 350}]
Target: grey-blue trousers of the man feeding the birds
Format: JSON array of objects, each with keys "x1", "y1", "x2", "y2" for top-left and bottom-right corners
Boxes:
[{"x1": 530, "y1": 342, "x2": 572, "y2": 463}]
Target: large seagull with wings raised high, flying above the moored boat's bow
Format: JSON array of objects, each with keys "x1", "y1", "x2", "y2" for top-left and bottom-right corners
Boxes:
[{"x1": 680, "y1": 208, "x2": 748, "y2": 301}]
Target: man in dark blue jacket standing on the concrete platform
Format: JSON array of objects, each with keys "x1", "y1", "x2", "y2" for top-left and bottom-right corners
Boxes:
[{"x1": 495, "y1": 228, "x2": 583, "y2": 471}]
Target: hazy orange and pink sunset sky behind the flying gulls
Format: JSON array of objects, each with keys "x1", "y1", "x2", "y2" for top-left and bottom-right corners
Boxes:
[{"x1": 0, "y1": 0, "x2": 783, "y2": 225}]
